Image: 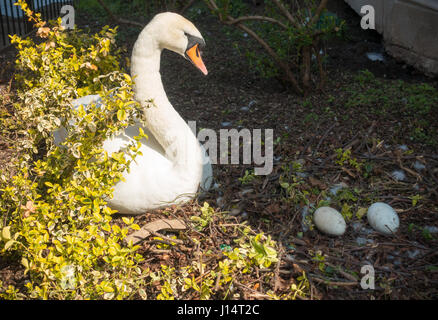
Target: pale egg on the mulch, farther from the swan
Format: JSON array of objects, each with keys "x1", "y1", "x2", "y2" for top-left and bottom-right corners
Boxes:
[{"x1": 367, "y1": 202, "x2": 400, "y2": 234}]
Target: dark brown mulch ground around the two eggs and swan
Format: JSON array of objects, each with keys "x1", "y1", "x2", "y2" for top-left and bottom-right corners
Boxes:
[{"x1": 0, "y1": 1, "x2": 438, "y2": 299}]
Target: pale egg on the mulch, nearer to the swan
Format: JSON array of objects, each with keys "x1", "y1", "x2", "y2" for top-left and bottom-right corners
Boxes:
[{"x1": 313, "y1": 207, "x2": 347, "y2": 236}]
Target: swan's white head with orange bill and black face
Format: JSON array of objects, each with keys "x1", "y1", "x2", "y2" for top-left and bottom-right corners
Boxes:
[{"x1": 147, "y1": 12, "x2": 208, "y2": 75}]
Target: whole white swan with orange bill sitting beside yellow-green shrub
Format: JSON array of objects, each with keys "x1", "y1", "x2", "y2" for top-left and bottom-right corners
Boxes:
[{"x1": 55, "y1": 12, "x2": 212, "y2": 214}]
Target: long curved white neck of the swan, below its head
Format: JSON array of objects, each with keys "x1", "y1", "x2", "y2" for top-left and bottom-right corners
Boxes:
[{"x1": 131, "y1": 27, "x2": 202, "y2": 175}]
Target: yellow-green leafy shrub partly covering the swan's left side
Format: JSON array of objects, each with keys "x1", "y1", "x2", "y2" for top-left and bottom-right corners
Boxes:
[{"x1": 0, "y1": 1, "x2": 149, "y2": 299}]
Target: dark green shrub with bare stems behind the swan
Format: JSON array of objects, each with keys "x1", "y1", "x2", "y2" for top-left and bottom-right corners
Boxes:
[{"x1": 205, "y1": 0, "x2": 345, "y2": 94}]
